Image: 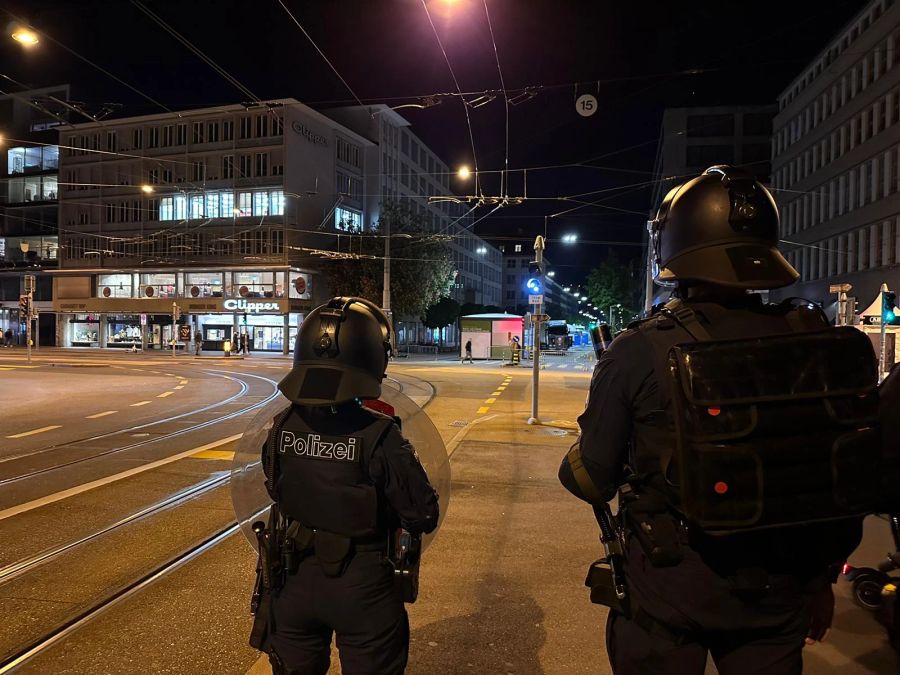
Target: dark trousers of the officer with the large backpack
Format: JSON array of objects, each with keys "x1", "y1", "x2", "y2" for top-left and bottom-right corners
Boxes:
[{"x1": 606, "y1": 540, "x2": 814, "y2": 675}]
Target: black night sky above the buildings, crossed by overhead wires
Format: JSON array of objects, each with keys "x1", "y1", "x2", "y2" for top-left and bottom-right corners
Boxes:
[{"x1": 0, "y1": 0, "x2": 865, "y2": 283}]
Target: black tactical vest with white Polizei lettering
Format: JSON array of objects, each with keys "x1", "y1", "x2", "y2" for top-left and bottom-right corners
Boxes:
[{"x1": 266, "y1": 406, "x2": 394, "y2": 540}]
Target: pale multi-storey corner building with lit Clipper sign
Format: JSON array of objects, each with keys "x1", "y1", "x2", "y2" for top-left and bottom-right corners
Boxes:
[{"x1": 53, "y1": 99, "x2": 377, "y2": 353}]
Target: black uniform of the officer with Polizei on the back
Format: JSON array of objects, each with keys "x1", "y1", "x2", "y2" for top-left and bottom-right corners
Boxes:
[{"x1": 264, "y1": 402, "x2": 438, "y2": 675}]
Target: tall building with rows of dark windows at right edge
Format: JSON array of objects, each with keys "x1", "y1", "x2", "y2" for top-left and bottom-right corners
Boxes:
[{"x1": 772, "y1": 0, "x2": 900, "y2": 307}]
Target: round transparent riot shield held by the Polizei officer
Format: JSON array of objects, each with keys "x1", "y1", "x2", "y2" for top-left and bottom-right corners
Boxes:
[{"x1": 231, "y1": 387, "x2": 450, "y2": 550}]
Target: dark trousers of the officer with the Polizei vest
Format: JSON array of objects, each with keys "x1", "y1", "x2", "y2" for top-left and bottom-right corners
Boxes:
[{"x1": 265, "y1": 551, "x2": 409, "y2": 675}]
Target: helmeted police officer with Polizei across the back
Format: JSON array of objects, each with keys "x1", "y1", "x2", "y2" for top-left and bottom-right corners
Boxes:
[{"x1": 251, "y1": 298, "x2": 438, "y2": 675}]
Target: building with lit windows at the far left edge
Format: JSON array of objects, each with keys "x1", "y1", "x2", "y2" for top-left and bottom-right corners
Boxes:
[{"x1": 0, "y1": 85, "x2": 69, "y2": 345}]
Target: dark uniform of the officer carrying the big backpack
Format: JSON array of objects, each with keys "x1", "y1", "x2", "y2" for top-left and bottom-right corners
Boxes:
[{"x1": 560, "y1": 295, "x2": 861, "y2": 675}]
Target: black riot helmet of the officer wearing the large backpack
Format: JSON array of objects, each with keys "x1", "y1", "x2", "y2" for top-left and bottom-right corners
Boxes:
[{"x1": 647, "y1": 166, "x2": 800, "y2": 289}]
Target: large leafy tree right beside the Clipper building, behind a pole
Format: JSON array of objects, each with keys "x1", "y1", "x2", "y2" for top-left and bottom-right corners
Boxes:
[{"x1": 323, "y1": 205, "x2": 455, "y2": 319}]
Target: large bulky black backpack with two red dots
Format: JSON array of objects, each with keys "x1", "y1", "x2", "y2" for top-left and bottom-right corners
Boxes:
[{"x1": 631, "y1": 300, "x2": 900, "y2": 535}]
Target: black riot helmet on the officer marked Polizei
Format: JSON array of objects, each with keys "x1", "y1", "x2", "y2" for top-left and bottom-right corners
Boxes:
[{"x1": 278, "y1": 298, "x2": 391, "y2": 406}]
